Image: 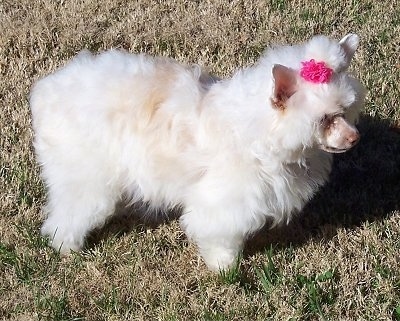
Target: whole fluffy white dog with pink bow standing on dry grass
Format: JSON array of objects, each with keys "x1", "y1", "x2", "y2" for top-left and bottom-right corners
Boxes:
[{"x1": 30, "y1": 34, "x2": 364, "y2": 269}]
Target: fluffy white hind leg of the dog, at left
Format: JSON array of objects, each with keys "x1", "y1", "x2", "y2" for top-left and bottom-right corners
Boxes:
[{"x1": 41, "y1": 165, "x2": 117, "y2": 253}]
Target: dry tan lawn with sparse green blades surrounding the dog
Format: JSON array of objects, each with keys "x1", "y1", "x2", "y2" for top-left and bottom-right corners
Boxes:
[{"x1": 0, "y1": 0, "x2": 400, "y2": 321}]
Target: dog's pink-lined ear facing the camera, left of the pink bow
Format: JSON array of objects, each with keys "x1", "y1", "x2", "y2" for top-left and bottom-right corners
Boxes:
[{"x1": 271, "y1": 64, "x2": 297, "y2": 109}]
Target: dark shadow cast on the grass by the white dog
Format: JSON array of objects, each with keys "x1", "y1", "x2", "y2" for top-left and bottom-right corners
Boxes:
[{"x1": 88, "y1": 116, "x2": 400, "y2": 255}]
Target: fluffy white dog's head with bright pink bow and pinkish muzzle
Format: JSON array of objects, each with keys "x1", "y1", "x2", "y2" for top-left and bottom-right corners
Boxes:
[{"x1": 271, "y1": 34, "x2": 364, "y2": 153}]
